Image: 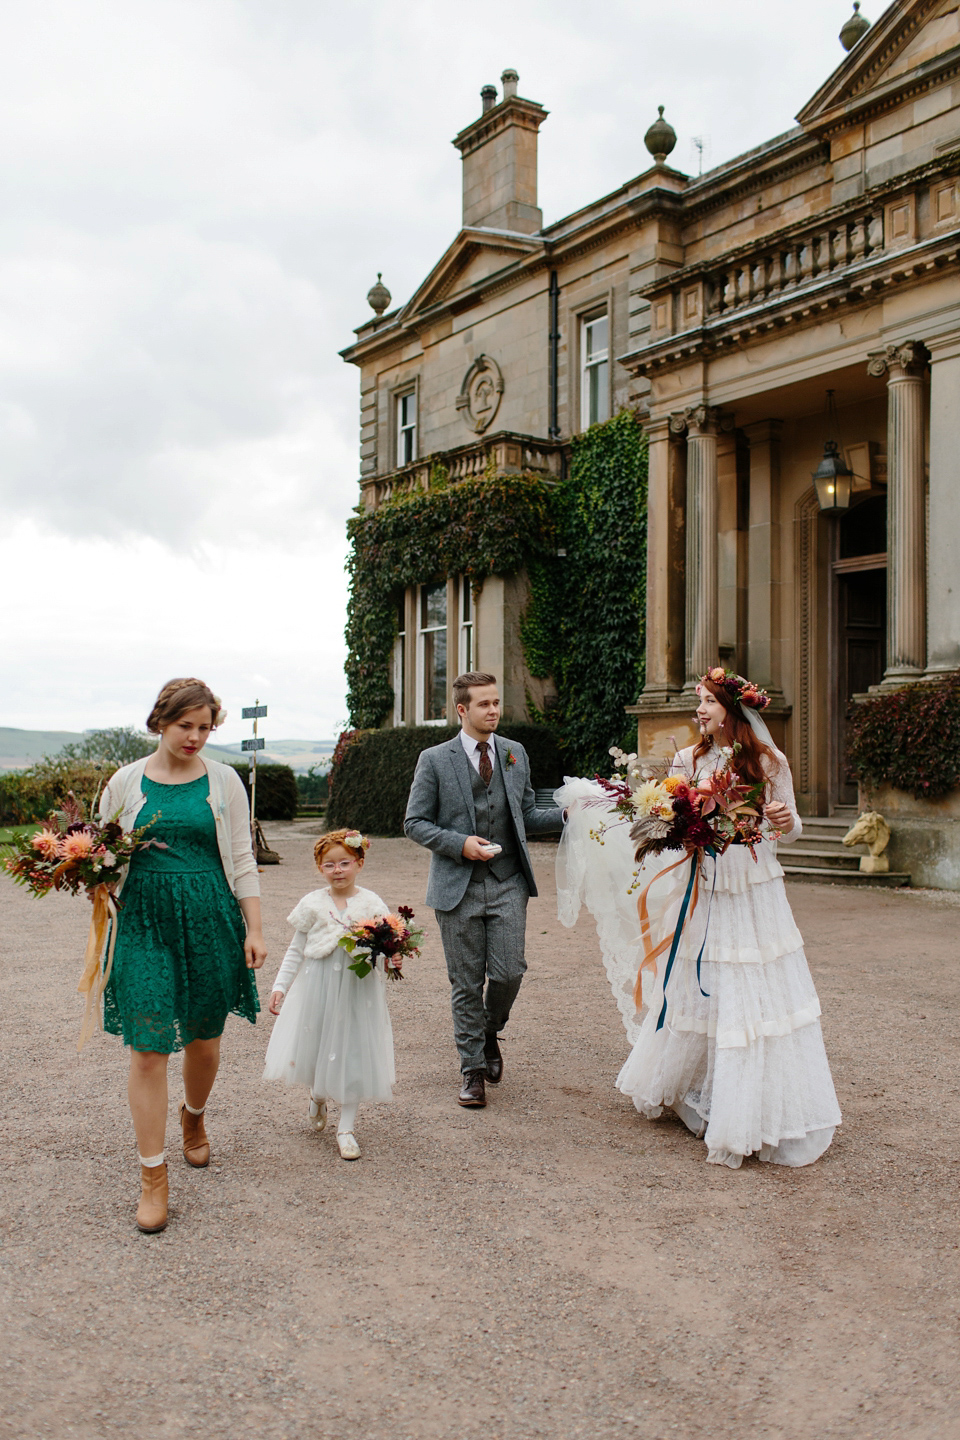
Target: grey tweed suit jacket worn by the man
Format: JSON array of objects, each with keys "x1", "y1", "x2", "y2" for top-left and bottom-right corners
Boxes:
[{"x1": 403, "y1": 734, "x2": 563, "y2": 910}]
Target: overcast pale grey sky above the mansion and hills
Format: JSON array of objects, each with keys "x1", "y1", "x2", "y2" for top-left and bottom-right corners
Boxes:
[{"x1": 0, "y1": 0, "x2": 881, "y2": 742}]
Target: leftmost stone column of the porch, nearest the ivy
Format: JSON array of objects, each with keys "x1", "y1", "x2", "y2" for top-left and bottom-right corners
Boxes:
[{"x1": 640, "y1": 416, "x2": 685, "y2": 708}]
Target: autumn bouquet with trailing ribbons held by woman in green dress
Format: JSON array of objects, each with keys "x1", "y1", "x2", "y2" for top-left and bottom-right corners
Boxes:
[{"x1": 3, "y1": 791, "x2": 167, "y2": 1050}]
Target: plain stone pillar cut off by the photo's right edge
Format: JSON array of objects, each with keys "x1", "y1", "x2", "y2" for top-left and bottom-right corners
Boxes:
[{"x1": 927, "y1": 334, "x2": 960, "y2": 677}]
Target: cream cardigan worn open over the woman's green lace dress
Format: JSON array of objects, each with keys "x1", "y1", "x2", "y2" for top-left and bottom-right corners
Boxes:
[{"x1": 99, "y1": 755, "x2": 261, "y2": 900}]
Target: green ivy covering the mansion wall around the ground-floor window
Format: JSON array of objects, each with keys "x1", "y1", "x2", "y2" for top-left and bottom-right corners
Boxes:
[{"x1": 347, "y1": 410, "x2": 646, "y2": 773}]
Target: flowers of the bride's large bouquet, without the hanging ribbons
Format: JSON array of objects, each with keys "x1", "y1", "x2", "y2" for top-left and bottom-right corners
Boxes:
[{"x1": 594, "y1": 746, "x2": 763, "y2": 864}]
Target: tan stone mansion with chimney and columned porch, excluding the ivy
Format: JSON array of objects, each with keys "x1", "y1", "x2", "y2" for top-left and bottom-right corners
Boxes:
[{"x1": 343, "y1": 0, "x2": 960, "y2": 840}]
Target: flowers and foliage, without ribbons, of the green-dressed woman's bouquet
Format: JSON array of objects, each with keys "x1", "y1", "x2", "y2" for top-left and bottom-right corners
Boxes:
[{"x1": 3, "y1": 791, "x2": 167, "y2": 899}]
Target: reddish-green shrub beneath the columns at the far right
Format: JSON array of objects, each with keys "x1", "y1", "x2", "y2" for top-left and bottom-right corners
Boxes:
[{"x1": 846, "y1": 671, "x2": 960, "y2": 801}]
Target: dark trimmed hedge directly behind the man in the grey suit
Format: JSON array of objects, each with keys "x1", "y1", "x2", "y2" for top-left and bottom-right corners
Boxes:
[{"x1": 327, "y1": 724, "x2": 563, "y2": 835}]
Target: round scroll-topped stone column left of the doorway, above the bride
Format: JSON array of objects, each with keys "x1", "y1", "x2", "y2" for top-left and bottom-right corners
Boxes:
[{"x1": 671, "y1": 405, "x2": 720, "y2": 694}]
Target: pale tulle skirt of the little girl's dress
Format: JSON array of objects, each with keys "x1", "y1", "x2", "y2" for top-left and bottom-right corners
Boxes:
[{"x1": 263, "y1": 949, "x2": 396, "y2": 1104}]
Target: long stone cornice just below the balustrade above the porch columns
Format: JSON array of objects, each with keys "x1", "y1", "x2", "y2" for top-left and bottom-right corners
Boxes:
[{"x1": 617, "y1": 230, "x2": 960, "y2": 376}]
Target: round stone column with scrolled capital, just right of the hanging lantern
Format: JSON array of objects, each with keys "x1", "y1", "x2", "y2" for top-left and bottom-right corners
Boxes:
[{"x1": 868, "y1": 340, "x2": 930, "y2": 687}]
